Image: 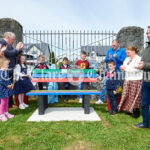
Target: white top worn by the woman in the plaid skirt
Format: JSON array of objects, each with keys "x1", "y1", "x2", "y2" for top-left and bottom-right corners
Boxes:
[{"x1": 123, "y1": 55, "x2": 143, "y2": 80}]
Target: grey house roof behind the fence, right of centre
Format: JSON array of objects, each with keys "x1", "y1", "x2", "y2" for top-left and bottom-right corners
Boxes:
[{"x1": 81, "y1": 46, "x2": 111, "y2": 56}]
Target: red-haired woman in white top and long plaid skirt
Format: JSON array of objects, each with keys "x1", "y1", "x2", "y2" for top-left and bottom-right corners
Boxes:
[{"x1": 118, "y1": 46, "x2": 143, "y2": 118}]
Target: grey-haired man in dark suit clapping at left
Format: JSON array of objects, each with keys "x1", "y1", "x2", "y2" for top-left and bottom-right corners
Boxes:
[{"x1": 0, "y1": 32, "x2": 24, "y2": 107}]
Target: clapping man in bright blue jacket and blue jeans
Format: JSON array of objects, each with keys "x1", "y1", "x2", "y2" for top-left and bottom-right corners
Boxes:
[{"x1": 95, "y1": 40, "x2": 126, "y2": 104}]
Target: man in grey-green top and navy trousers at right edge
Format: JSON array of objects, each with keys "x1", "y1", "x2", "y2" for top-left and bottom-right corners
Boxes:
[{"x1": 133, "y1": 26, "x2": 150, "y2": 128}]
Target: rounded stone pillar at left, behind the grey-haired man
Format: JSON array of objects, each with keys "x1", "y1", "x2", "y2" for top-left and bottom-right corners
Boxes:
[{"x1": 0, "y1": 18, "x2": 23, "y2": 45}]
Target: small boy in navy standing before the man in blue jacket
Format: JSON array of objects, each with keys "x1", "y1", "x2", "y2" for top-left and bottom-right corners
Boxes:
[{"x1": 106, "y1": 60, "x2": 120, "y2": 115}]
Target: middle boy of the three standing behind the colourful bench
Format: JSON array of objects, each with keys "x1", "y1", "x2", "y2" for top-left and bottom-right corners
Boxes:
[{"x1": 60, "y1": 57, "x2": 70, "y2": 102}]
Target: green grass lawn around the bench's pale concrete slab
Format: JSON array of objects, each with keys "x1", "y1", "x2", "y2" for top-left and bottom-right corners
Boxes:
[{"x1": 0, "y1": 99, "x2": 150, "y2": 150}]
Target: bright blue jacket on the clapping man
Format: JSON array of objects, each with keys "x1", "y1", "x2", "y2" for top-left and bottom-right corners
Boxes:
[{"x1": 105, "y1": 48, "x2": 126, "y2": 70}]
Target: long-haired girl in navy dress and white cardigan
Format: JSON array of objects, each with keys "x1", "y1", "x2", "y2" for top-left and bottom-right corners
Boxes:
[{"x1": 14, "y1": 55, "x2": 35, "y2": 109}]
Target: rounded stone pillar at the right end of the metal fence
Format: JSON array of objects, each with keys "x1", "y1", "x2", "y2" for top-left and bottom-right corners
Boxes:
[{"x1": 117, "y1": 26, "x2": 144, "y2": 50}]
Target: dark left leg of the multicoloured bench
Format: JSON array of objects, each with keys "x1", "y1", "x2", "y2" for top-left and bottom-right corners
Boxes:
[{"x1": 38, "y1": 95, "x2": 45, "y2": 115}]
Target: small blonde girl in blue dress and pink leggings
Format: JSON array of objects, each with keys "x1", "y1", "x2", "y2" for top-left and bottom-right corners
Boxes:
[{"x1": 0, "y1": 58, "x2": 14, "y2": 121}]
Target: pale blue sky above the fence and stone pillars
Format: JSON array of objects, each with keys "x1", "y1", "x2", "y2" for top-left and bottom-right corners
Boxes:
[{"x1": 0, "y1": 0, "x2": 150, "y2": 32}]
